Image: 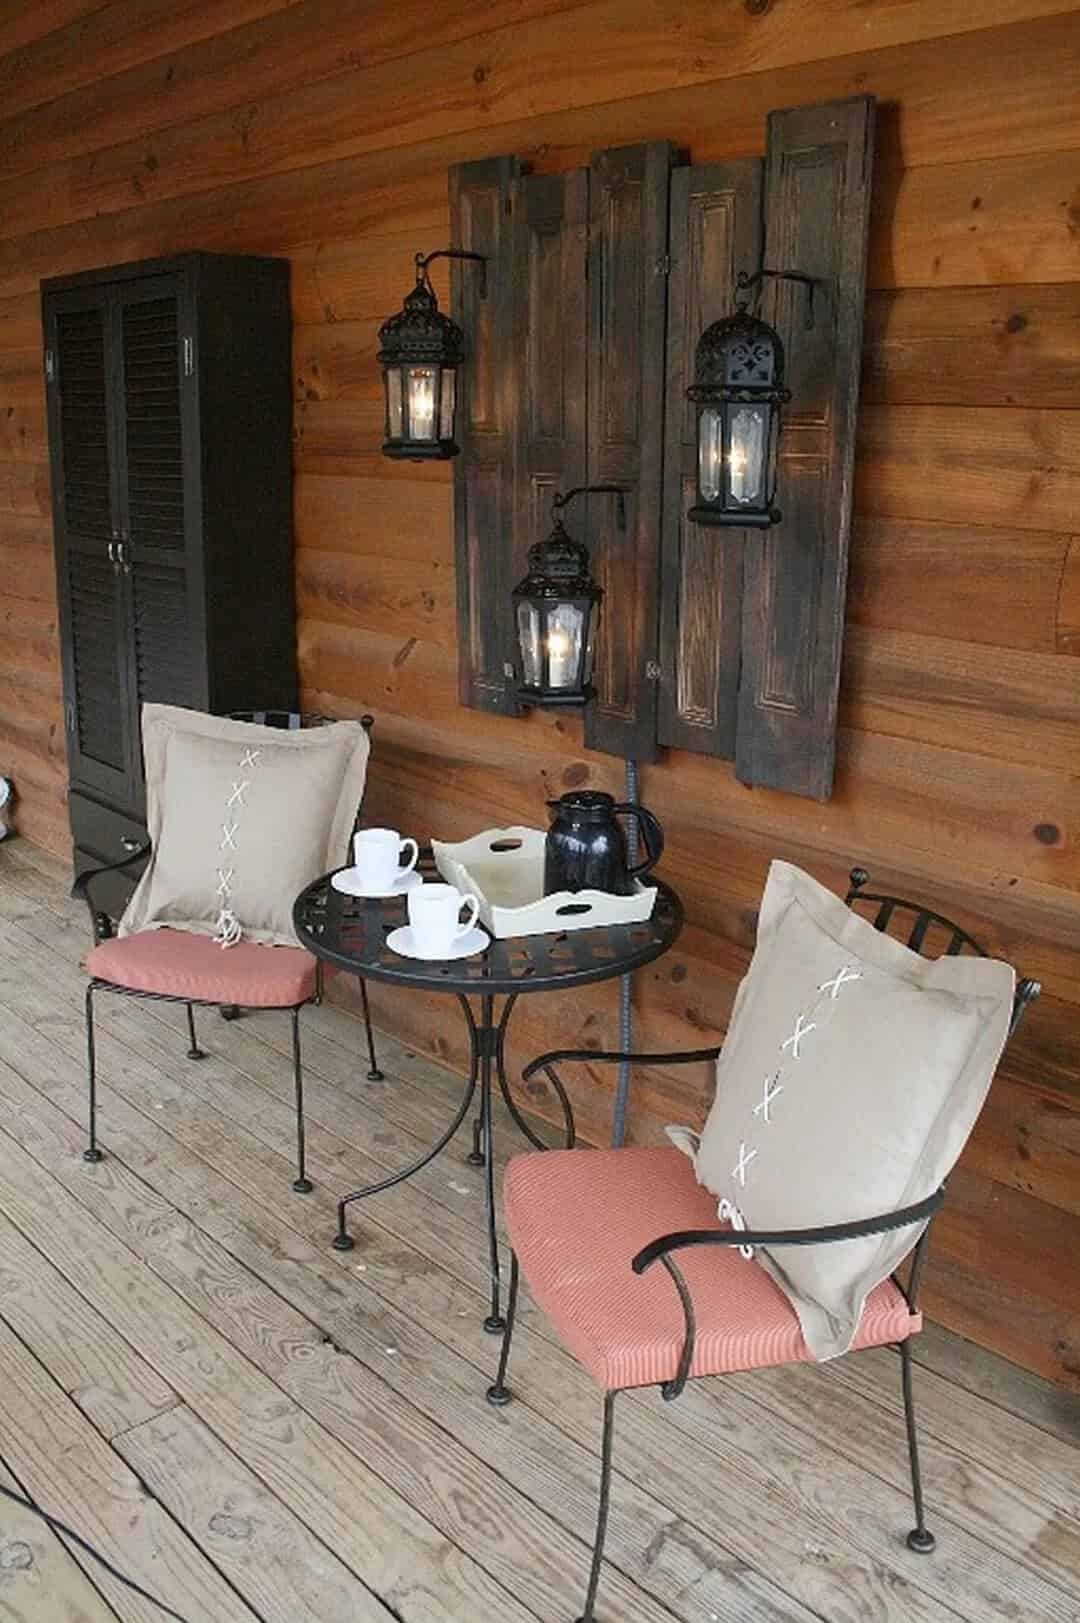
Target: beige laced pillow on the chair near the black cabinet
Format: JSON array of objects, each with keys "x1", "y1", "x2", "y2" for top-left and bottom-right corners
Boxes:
[{"x1": 120, "y1": 704, "x2": 369, "y2": 946}]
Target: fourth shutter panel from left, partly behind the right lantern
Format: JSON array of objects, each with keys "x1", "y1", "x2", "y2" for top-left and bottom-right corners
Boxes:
[{"x1": 659, "y1": 159, "x2": 763, "y2": 760}]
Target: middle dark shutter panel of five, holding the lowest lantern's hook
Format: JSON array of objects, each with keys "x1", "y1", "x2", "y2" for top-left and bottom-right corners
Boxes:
[{"x1": 581, "y1": 141, "x2": 676, "y2": 761}]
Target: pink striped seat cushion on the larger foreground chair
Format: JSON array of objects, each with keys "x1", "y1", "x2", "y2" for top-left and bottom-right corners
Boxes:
[{"x1": 503, "y1": 1147, "x2": 922, "y2": 1391}]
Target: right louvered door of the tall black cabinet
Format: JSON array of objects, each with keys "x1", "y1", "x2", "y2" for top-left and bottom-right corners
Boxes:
[{"x1": 117, "y1": 276, "x2": 205, "y2": 759}]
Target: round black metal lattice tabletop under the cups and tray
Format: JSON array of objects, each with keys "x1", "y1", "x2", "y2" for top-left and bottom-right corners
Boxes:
[{"x1": 292, "y1": 862, "x2": 682, "y2": 995}]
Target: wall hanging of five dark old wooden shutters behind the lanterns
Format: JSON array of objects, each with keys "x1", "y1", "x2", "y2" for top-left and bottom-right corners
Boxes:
[{"x1": 450, "y1": 96, "x2": 874, "y2": 797}]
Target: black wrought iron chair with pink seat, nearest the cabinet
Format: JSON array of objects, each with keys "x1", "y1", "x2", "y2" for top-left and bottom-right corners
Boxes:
[{"x1": 71, "y1": 711, "x2": 383, "y2": 1195}]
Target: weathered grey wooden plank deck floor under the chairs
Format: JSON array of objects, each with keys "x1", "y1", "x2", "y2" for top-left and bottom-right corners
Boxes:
[{"x1": 0, "y1": 841, "x2": 1080, "y2": 1623}]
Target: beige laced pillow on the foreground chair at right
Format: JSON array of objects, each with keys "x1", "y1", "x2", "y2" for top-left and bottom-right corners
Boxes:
[{"x1": 667, "y1": 862, "x2": 1015, "y2": 1358}]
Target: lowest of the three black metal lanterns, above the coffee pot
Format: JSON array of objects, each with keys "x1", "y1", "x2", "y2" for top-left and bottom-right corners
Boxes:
[{"x1": 513, "y1": 485, "x2": 625, "y2": 704}]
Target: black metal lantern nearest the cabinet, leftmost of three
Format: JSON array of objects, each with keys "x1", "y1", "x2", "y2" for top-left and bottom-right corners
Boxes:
[{"x1": 378, "y1": 248, "x2": 486, "y2": 461}]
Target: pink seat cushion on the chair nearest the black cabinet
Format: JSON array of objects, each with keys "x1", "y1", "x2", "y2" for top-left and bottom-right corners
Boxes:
[{"x1": 86, "y1": 930, "x2": 315, "y2": 1008}]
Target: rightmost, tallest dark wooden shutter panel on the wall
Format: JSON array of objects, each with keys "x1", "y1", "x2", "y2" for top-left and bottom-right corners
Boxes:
[{"x1": 736, "y1": 96, "x2": 874, "y2": 799}]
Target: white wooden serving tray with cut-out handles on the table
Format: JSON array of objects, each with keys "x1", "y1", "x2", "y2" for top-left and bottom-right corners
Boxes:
[{"x1": 432, "y1": 826, "x2": 656, "y2": 940}]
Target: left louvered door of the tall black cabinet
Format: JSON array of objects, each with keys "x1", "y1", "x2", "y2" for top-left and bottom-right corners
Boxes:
[{"x1": 45, "y1": 289, "x2": 132, "y2": 799}]
